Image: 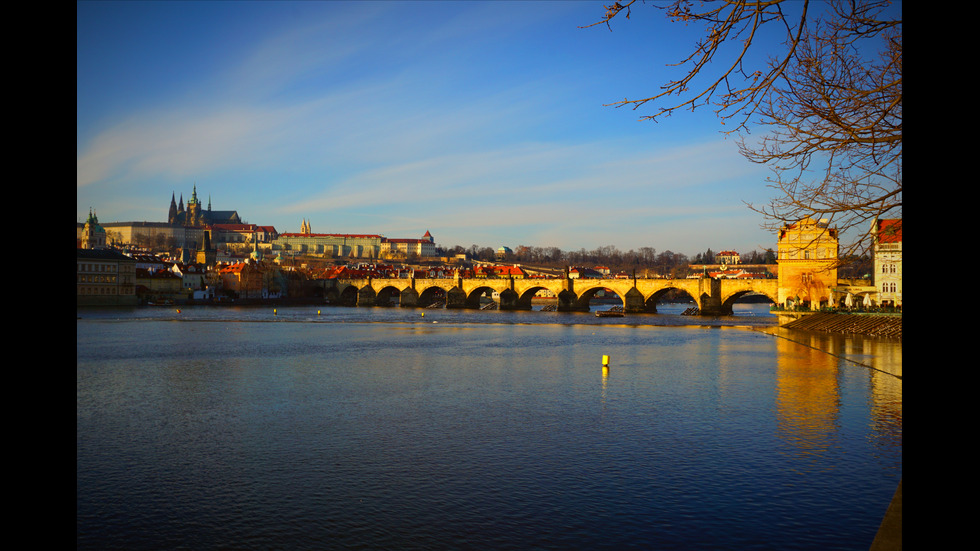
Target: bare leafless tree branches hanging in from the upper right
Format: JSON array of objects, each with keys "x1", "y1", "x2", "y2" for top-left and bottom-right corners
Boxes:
[{"x1": 587, "y1": 0, "x2": 902, "y2": 256}]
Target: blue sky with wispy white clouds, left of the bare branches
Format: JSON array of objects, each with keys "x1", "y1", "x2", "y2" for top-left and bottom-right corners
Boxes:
[{"x1": 76, "y1": 0, "x2": 792, "y2": 255}]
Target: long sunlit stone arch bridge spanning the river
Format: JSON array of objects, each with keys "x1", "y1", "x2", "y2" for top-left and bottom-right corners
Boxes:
[{"x1": 324, "y1": 277, "x2": 778, "y2": 316}]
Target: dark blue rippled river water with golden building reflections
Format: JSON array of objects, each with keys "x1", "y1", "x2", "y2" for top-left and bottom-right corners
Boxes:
[{"x1": 76, "y1": 305, "x2": 902, "y2": 550}]
